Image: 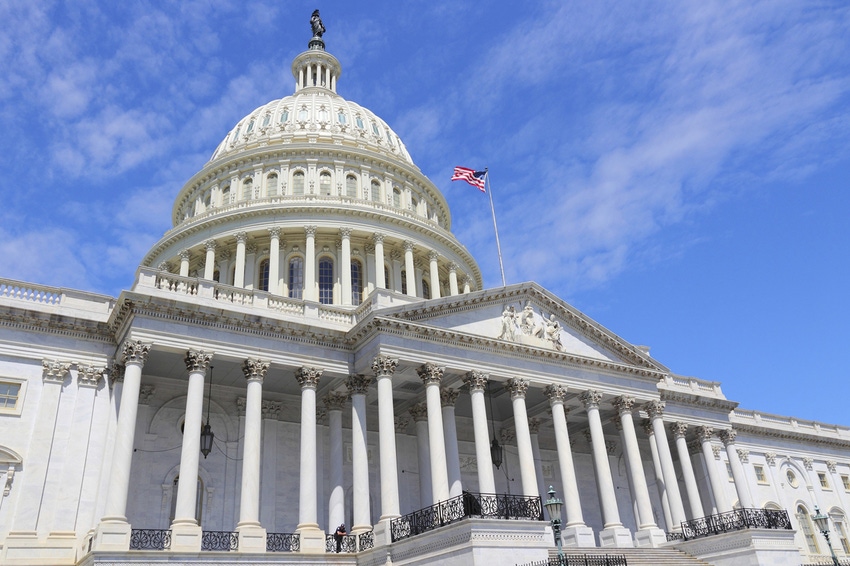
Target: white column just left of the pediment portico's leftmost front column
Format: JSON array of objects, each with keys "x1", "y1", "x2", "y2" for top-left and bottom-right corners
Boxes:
[{"x1": 345, "y1": 375, "x2": 372, "y2": 533}]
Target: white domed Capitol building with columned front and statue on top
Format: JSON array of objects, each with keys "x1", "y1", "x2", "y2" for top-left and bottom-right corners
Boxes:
[{"x1": 0, "y1": 13, "x2": 850, "y2": 566}]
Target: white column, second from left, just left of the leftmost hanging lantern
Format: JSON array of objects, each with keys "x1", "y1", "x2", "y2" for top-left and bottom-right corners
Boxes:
[{"x1": 170, "y1": 349, "x2": 213, "y2": 552}]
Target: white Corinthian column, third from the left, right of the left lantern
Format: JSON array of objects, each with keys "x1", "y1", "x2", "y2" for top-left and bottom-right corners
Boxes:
[{"x1": 236, "y1": 358, "x2": 269, "y2": 552}]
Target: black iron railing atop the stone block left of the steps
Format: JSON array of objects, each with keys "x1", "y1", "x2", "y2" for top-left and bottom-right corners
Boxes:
[{"x1": 390, "y1": 492, "x2": 543, "y2": 542}]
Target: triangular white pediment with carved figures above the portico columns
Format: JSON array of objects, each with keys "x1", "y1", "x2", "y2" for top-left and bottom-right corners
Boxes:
[{"x1": 380, "y1": 283, "x2": 667, "y2": 372}]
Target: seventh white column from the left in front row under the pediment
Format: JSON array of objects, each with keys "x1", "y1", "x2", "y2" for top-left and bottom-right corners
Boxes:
[{"x1": 613, "y1": 395, "x2": 667, "y2": 547}]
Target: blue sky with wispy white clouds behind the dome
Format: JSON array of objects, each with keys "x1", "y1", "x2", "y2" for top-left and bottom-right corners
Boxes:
[{"x1": 0, "y1": 0, "x2": 850, "y2": 424}]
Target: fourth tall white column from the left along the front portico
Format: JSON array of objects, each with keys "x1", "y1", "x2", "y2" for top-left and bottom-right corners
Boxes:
[{"x1": 295, "y1": 366, "x2": 325, "y2": 554}]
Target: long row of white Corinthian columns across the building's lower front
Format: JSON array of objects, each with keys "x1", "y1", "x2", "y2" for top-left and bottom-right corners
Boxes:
[{"x1": 95, "y1": 341, "x2": 752, "y2": 552}]
